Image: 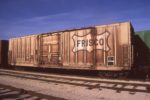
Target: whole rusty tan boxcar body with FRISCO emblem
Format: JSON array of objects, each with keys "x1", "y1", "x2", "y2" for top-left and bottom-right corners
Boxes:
[{"x1": 9, "y1": 22, "x2": 134, "y2": 71}]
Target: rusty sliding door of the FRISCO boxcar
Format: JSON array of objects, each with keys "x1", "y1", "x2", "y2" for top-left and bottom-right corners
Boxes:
[{"x1": 39, "y1": 33, "x2": 60, "y2": 67}]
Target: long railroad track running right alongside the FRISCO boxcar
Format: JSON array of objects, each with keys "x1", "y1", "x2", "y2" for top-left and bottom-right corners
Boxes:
[{"x1": 0, "y1": 69, "x2": 150, "y2": 93}]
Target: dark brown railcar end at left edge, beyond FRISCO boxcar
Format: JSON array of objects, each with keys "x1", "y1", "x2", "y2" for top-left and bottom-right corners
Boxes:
[{"x1": 0, "y1": 40, "x2": 8, "y2": 67}]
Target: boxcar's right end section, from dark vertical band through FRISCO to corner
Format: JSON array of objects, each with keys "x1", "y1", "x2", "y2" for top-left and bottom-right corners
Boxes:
[{"x1": 96, "y1": 23, "x2": 131, "y2": 70}]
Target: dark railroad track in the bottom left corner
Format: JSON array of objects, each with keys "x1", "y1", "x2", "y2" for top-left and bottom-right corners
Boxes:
[{"x1": 0, "y1": 84, "x2": 65, "y2": 100}]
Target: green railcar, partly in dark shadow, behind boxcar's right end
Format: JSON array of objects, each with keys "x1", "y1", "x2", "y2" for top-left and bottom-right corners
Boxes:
[{"x1": 134, "y1": 30, "x2": 150, "y2": 75}]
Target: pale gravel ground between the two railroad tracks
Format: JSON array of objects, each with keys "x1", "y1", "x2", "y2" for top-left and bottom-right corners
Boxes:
[{"x1": 0, "y1": 72, "x2": 150, "y2": 100}]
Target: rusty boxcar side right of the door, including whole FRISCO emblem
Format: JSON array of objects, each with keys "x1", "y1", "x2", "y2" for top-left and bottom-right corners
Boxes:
[{"x1": 61, "y1": 22, "x2": 132, "y2": 70}]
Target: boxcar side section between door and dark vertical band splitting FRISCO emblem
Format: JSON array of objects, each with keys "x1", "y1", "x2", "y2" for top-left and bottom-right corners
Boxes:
[{"x1": 61, "y1": 29, "x2": 93, "y2": 68}]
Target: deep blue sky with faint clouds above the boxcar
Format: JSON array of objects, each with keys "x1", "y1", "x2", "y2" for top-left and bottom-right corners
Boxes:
[{"x1": 0, "y1": 0, "x2": 150, "y2": 39}]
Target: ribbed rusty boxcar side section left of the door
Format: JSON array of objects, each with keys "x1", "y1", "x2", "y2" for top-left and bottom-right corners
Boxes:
[{"x1": 9, "y1": 35, "x2": 37, "y2": 66}]
